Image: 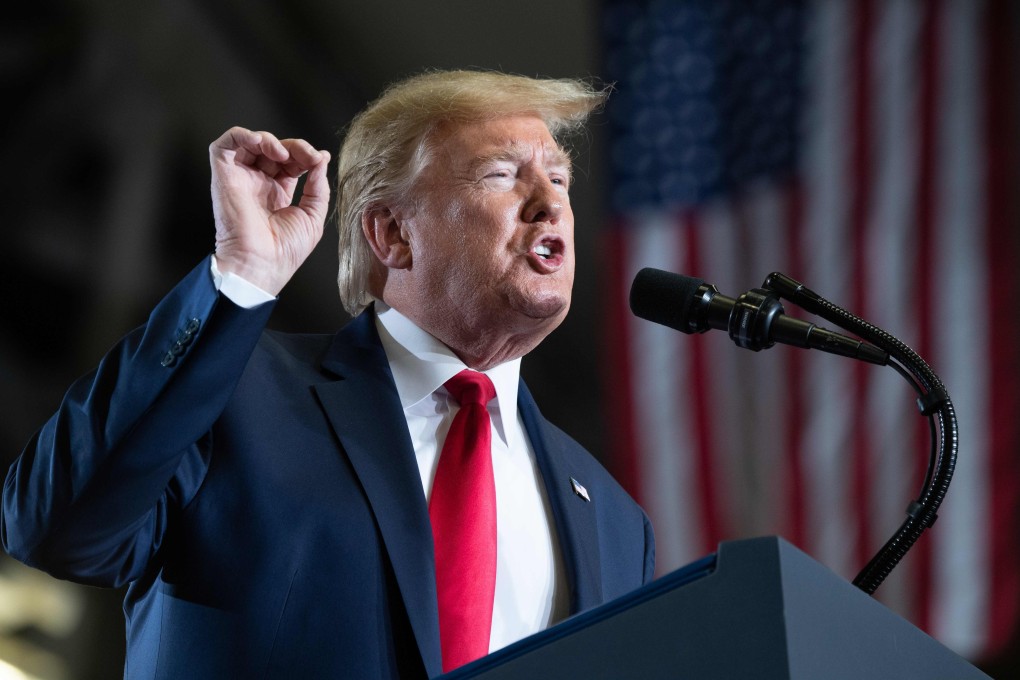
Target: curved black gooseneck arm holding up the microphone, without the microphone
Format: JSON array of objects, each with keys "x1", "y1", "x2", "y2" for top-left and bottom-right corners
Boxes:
[{"x1": 764, "y1": 272, "x2": 960, "y2": 593}]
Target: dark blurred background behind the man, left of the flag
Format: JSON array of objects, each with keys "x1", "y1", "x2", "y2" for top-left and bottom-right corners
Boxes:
[{"x1": 0, "y1": 0, "x2": 1016, "y2": 680}]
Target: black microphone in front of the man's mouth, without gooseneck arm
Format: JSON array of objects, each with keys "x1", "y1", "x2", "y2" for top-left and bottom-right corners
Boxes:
[{"x1": 630, "y1": 268, "x2": 889, "y2": 366}]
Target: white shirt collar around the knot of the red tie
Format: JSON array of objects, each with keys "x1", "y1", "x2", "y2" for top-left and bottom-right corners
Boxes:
[{"x1": 375, "y1": 301, "x2": 520, "y2": 446}]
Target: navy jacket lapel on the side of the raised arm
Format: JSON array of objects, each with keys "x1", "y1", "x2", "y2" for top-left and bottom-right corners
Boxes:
[{"x1": 315, "y1": 312, "x2": 443, "y2": 677}]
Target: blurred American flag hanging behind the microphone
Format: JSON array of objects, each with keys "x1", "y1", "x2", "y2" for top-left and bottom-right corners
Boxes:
[{"x1": 603, "y1": 0, "x2": 1020, "y2": 660}]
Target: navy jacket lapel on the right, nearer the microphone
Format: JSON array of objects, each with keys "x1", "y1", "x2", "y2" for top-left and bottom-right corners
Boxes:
[{"x1": 517, "y1": 380, "x2": 603, "y2": 614}]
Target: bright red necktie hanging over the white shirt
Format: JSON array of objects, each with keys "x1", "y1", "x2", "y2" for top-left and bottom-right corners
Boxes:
[{"x1": 428, "y1": 370, "x2": 496, "y2": 673}]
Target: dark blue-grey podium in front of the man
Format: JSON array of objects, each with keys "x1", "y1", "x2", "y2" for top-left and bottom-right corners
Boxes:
[{"x1": 442, "y1": 536, "x2": 988, "y2": 680}]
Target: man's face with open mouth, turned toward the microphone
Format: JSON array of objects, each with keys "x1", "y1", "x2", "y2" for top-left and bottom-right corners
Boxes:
[{"x1": 402, "y1": 115, "x2": 574, "y2": 339}]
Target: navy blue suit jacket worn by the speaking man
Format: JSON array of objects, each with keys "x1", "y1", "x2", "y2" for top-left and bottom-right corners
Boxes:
[{"x1": 0, "y1": 257, "x2": 654, "y2": 679}]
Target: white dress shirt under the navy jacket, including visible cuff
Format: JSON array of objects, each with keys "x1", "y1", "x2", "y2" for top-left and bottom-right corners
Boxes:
[{"x1": 210, "y1": 257, "x2": 569, "y2": 651}]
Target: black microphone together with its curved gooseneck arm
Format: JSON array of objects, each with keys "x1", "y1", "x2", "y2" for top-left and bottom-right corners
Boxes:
[{"x1": 630, "y1": 269, "x2": 959, "y2": 594}]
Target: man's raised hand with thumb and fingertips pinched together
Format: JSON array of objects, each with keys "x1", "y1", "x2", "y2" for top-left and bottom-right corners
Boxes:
[{"x1": 209, "y1": 127, "x2": 329, "y2": 295}]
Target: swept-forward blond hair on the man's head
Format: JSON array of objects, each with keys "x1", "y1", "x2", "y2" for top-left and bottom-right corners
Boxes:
[{"x1": 337, "y1": 70, "x2": 608, "y2": 315}]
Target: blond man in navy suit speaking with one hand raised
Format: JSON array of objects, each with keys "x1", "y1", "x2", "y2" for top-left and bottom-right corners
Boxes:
[{"x1": 0, "y1": 71, "x2": 654, "y2": 678}]
